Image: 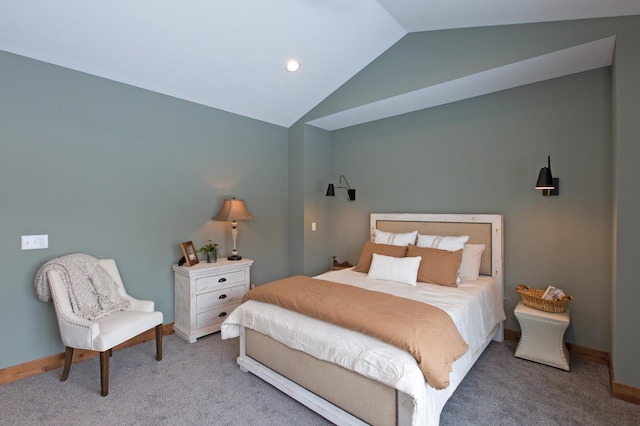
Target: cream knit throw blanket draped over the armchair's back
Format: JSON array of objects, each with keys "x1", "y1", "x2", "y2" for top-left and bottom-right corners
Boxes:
[{"x1": 34, "y1": 253, "x2": 130, "y2": 320}]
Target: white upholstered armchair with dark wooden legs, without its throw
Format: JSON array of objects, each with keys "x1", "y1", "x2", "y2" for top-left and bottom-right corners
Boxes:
[{"x1": 47, "y1": 259, "x2": 162, "y2": 396}]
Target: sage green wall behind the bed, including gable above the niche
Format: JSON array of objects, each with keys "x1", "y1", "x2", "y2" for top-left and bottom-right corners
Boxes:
[{"x1": 301, "y1": 16, "x2": 640, "y2": 388}]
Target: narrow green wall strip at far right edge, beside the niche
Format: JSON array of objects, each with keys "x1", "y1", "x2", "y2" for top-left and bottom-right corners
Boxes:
[{"x1": 612, "y1": 18, "x2": 640, "y2": 390}]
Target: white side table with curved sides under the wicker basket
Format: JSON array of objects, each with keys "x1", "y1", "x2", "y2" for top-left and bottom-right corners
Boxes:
[{"x1": 513, "y1": 302, "x2": 571, "y2": 371}]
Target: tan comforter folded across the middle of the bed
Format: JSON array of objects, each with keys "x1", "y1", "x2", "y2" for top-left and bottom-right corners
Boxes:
[{"x1": 244, "y1": 275, "x2": 469, "y2": 389}]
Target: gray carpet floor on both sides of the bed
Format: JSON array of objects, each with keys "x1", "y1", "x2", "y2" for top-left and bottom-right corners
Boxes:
[{"x1": 0, "y1": 333, "x2": 640, "y2": 426}]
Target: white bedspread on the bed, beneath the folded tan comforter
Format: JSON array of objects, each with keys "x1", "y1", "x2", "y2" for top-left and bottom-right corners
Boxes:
[{"x1": 221, "y1": 269, "x2": 505, "y2": 425}]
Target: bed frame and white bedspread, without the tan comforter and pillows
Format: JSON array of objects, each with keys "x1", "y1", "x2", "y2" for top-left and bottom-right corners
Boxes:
[{"x1": 222, "y1": 214, "x2": 505, "y2": 425}]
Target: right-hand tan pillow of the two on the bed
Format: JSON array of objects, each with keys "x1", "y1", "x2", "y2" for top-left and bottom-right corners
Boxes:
[{"x1": 407, "y1": 244, "x2": 462, "y2": 287}]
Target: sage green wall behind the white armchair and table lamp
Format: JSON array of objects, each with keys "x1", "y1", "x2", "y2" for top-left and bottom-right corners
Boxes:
[{"x1": 0, "y1": 52, "x2": 288, "y2": 368}]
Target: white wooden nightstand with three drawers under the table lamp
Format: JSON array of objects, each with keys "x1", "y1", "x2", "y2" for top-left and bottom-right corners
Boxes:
[{"x1": 172, "y1": 259, "x2": 253, "y2": 343}]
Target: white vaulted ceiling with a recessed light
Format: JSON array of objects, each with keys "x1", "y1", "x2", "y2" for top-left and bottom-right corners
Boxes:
[{"x1": 0, "y1": 0, "x2": 640, "y2": 127}]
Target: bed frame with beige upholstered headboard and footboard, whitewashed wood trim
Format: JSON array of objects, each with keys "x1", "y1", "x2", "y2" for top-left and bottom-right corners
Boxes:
[{"x1": 238, "y1": 214, "x2": 504, "y2": 425}]
